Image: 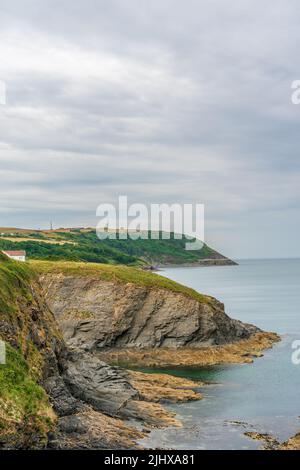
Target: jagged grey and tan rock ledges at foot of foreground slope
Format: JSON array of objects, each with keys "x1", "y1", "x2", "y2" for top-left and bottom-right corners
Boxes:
[{"x1": 45, "y1": 353, "x2": 202, "y2": 449}]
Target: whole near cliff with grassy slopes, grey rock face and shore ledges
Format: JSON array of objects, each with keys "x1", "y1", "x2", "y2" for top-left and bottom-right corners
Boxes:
[{"x1": 0, "y1": 255, "x2": 276, "y2": 449}]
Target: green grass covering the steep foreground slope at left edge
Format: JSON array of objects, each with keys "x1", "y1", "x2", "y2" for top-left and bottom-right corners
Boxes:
[{"x1": 0, "y1": 253, "x2": 53, "y2": 447}]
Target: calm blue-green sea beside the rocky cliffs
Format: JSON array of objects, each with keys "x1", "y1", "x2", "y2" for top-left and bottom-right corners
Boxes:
[{"x1": 143, "y1": 260, "x2": 300, "y2": 449}]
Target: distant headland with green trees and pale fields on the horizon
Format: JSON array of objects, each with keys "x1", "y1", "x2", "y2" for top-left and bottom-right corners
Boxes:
[{"x1": 0, "y1": 227, "x2": 236, "y2": 269}]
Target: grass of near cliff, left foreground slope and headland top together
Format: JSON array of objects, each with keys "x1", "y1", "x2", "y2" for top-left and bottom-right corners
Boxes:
[{"x1": 0, "y1": 252, "x2": 210, "y2": 448}]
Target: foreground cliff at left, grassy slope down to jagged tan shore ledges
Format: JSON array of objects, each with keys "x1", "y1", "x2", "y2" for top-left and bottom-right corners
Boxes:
[{"x1": 0, "y1": 254, "x2": 201, "y2": 449}]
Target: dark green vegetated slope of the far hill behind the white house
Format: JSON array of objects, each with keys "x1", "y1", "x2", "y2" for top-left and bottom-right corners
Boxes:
[{"x1": 0, "y1": 229, "x2": 231, "y2": 265}]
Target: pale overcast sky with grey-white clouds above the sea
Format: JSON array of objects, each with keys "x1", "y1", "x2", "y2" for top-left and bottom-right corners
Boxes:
[{"x1": 0, "y1": 0, "x2": 300, "y2": 258}]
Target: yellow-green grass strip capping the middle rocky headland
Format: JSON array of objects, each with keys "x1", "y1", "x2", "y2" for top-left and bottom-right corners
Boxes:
[{"x1": 29, "y1": 261, "x2": 210, "y2": 303}]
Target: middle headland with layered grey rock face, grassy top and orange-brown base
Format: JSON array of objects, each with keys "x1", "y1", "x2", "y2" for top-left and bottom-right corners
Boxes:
[{"x1": 39, "y1": 263, "x2": 278, "y2": 365}]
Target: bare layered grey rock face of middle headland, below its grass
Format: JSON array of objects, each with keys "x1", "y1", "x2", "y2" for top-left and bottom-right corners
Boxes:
[{"x1": 41, "y1": 274, "x2": 259, "y2": 351}]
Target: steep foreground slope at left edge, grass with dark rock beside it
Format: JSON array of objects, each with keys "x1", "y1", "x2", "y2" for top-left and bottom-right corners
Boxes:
[{"x1": 0, "y1": 254, "x2": 64, "y2": 448}]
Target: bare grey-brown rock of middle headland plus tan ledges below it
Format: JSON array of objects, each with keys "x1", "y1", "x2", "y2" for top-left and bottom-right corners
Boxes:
[{"x1": 35, "y1": 264, "x2": 279, "y2": 446}]
